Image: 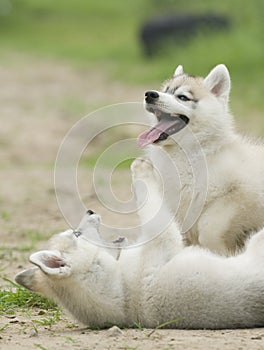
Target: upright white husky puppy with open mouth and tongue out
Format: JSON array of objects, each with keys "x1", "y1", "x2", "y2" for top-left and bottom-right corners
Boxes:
[{"x1": 138, "y1": 64, "x2": 264, "y2": 255}]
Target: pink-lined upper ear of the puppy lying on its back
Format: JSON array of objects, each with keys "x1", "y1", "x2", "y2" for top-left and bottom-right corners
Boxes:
[{"x1": 29, "y1": 250, "x2": 71, "y2": 277}]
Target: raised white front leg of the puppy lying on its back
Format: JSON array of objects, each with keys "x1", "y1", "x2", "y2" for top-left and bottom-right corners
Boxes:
[{"x1": 131, "y1": 158, "x2": 182, "y2": 250}]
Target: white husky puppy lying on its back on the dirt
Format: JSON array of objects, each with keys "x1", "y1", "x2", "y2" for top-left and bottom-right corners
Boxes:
[{"x1": 16, "y1": 159, "x2": 264, "y2": 329}]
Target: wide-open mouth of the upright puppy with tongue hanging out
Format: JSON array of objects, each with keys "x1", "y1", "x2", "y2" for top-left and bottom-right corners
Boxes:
[{"x1": 137, "y1": 107, "x2": 189, "y2": 147}]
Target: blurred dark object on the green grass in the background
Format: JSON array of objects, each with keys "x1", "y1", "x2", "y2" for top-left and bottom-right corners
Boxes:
[{"x1": 140, "y1": 13, "x2": 230, "y2": 56}]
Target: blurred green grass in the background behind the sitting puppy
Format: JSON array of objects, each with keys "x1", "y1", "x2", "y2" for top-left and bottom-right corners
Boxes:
[{"x1": 0, "y1": 0, "x2": 264, "y2": 123}]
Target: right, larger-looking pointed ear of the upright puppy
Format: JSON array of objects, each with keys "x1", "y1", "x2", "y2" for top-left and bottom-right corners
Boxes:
[{"x1": 204, "y1": 64, "x2": 231, "y2": 105}]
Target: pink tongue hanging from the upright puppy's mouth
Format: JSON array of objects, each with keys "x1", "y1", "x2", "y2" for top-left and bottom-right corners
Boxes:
[{"x1": 137, "y1": 119, "x2": 175, "y2": 147}]
